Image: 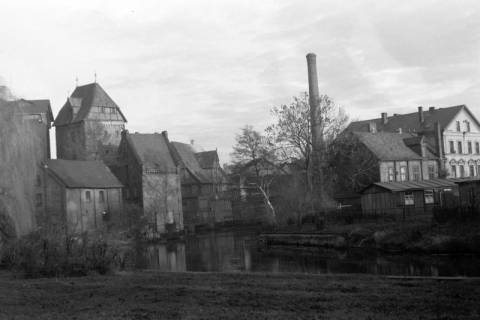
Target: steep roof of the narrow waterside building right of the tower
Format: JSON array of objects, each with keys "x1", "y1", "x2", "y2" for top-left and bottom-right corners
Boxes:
[{"x1": 125, "y1": 133, "x2": 177, "y2": 173}]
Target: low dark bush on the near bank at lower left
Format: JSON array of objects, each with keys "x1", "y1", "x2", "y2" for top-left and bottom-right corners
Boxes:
[{"x1": 1, "y1": 231, "x2": 118, "y2": 277}]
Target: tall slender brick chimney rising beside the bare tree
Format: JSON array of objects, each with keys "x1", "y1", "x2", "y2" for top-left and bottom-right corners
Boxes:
[{"x1": 307, "y1": 53, "x2": 325, "y2": 209}]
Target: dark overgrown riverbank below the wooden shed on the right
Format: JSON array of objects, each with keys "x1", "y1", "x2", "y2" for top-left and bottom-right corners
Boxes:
[{"x1": 270, "y1": 219, "x2": 480, "y2": 254}]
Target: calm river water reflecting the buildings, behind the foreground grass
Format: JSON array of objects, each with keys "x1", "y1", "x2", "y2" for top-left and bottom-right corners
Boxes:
[{"x1": 129, "y1": 232, "x2": 480, "y2": 276}]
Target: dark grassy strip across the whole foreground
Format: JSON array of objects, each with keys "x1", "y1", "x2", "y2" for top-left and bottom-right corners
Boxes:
[{"x1": 0, "y1": 271, "x2": 480, "y2": 320}]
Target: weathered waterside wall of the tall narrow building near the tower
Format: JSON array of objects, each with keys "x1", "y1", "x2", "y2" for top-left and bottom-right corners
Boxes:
[{"x1": 142, "y1": 171, "x2": 183, "y2": 234}]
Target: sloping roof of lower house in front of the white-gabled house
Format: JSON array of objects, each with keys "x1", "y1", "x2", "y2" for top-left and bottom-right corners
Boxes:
[{"x1": 352, "y1": 132, "x2": 436, "y2": 160}]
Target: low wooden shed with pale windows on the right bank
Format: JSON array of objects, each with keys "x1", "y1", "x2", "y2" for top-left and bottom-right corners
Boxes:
[{"x1": 361, "y1": 179, "x2": 459, "y2": 214}]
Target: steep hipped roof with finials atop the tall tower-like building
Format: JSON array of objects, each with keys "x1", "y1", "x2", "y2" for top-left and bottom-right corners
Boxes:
[{"x1": 54, "y1": 83, "x2": 127, "y2": 126}]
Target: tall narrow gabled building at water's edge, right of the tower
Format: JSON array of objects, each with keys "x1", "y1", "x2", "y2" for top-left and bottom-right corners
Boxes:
[{"x1": 116, "y1": 131, "x2": 183, "y2": 237}]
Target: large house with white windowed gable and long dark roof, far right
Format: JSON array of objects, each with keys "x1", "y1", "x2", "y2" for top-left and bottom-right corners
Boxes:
[{"x1": 347, "y1": 105, "x2": 480, "y2": 178}]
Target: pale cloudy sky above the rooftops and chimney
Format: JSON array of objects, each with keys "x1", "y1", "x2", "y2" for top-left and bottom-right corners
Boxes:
[{"x1": 0, "y1": 0, "x2": 480, "y2": 162}]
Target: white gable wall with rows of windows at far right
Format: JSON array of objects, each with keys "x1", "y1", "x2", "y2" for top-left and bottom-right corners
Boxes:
[{"x1": 443, "y1": 109, "x2": 480, "y2": 178}]
